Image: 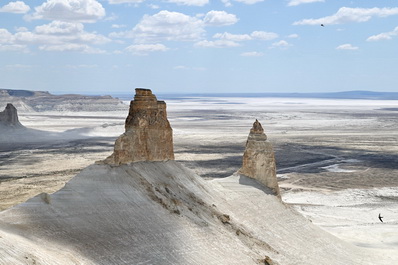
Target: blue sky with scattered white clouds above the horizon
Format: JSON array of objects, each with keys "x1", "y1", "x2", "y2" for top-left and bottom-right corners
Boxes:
[{"x1": 0, "y1": 0, "x2": 398, "y2": 94}]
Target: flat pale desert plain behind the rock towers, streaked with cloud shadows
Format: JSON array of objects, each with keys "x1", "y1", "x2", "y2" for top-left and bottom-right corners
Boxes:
[{"x1": 0, "y1": 98, "x2": 398, "y2": 258}]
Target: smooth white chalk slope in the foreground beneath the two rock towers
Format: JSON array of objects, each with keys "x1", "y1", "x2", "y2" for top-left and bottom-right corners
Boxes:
[{"x1": 0, "y1": 161, "x2": 388, "y2": 265}]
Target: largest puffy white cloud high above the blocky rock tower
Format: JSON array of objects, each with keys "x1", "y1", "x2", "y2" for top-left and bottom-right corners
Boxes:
[{"x1": 131, "y1": 10, "x2": 205, "y2": 43}]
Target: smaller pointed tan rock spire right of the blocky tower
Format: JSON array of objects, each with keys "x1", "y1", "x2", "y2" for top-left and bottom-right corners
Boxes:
[{"x1": 238, "y1": 120, "x2": 280, "y2": 197}]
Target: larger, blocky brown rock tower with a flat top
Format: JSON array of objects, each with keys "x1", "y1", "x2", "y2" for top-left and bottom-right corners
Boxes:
[{"x1": 104, "y1": 88, "x2": 174, "y2": 165}]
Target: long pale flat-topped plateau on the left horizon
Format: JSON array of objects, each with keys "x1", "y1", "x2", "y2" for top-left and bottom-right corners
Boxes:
[{"x1": 0, "y1": 89, "x2": 127, "y2": 112}]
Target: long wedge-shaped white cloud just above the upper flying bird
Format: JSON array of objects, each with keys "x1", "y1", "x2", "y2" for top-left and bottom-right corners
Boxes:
[{"x1": 293, "y1": 7, "x2": 398, "y2": 25}]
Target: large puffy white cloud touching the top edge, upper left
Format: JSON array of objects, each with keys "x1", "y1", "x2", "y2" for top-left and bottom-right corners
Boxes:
[{"x1": 27, "y1": 0, "x2": 105, "y2": 23}]
